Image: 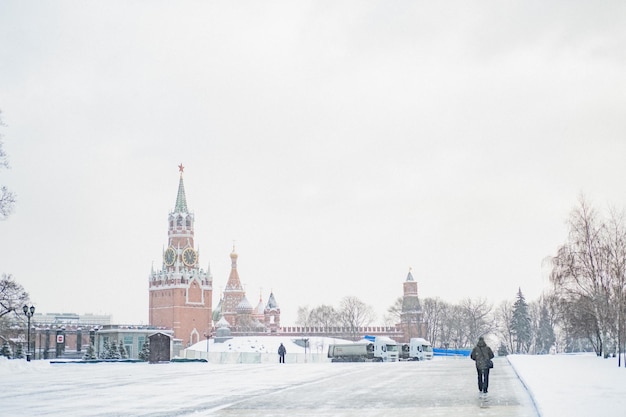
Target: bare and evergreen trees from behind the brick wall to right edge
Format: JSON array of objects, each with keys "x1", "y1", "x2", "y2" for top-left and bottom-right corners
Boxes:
[{"x1": 298, "y1": 197, "x2": 626, "y2": 365}]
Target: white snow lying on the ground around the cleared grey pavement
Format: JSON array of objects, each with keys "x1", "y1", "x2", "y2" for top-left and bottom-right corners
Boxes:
[{"x1": 0, "y1": 337, "x2": 626, "y2": 417}]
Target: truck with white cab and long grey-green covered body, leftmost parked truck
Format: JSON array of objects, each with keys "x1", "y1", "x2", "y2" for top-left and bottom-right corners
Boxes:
[{"x1": 328, "y1": 336, "x2": 398, "y2": 362}]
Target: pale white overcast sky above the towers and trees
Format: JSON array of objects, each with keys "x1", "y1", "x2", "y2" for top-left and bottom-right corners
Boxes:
[{"x1": 0, "y1": 0, "x2": 626, "y2": 324}]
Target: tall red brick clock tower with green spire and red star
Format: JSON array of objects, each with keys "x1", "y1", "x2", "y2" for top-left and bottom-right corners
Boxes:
[{"x1": 149, "y1": 164, "x2": 213, "y2": 346}]
